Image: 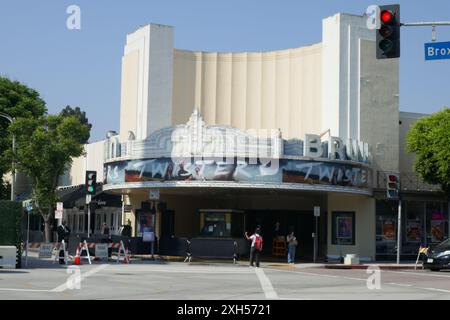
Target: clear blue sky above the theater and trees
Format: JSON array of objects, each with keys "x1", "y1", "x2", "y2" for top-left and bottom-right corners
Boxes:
[{"x1": 0, "y1": 0, "x2": 450, "y2": 140}]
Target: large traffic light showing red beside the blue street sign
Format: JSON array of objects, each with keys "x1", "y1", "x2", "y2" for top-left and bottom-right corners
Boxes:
[{"x1": 376, "y1": 4, "x2": 400, "y2": 59}]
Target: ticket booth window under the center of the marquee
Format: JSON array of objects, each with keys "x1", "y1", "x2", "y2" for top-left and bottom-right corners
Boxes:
[{"x1": 199, "y1": 210, "x2": 244, "y2": 238}]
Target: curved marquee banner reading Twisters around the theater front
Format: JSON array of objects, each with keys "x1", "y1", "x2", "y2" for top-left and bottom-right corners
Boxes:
[{"x1": 105, "y1": 158, "x2": 371, "y2": 189}]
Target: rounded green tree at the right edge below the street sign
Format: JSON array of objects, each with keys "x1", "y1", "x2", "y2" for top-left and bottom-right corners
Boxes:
[{"x1": 406, "y1": 107, "x2": 450, "y2": 196}]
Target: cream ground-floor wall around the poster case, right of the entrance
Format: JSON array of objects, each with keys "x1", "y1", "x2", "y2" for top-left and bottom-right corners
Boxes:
[{"x1": 327, "y1": 194, "x2": 375, "y2": 260}]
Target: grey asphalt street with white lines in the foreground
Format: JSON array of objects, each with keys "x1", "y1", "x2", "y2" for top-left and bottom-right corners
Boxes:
[{"x1": 0, "y1": 261, "x2": 450, "y2": 300}]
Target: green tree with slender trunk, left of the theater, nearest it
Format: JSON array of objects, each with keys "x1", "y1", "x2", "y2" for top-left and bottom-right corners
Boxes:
[{"x1": 10, "y1": 115, "x2": 89, "y2": 241}]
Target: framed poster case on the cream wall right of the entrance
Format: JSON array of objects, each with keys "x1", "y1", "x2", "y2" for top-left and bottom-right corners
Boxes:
[{"x1": 332, "y1": 211, "x2": 355, "y2": 245}]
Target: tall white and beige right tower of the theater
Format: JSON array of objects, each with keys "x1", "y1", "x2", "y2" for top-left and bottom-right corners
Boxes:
[{"x1": 322, "y1": 14, "x2": 399, "y2": 174}]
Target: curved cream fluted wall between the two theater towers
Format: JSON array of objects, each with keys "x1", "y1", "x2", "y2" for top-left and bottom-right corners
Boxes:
[{"x1": 172, "y1": 44, "x2": 322, "y2": 139}]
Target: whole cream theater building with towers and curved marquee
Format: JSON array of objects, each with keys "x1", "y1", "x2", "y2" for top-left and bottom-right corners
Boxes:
[{"x1": 61, "y1": 14, "x2": 449, "y2": 261}]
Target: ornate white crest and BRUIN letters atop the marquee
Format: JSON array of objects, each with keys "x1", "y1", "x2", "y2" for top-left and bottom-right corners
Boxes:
[{"x1": 106, "y1": 110, "x2": 372, "y2": 164}]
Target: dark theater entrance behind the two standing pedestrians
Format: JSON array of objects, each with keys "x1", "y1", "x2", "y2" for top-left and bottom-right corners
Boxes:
[{"x1": 246, "y1": 210, "x2": 327, "y2": 262}]
